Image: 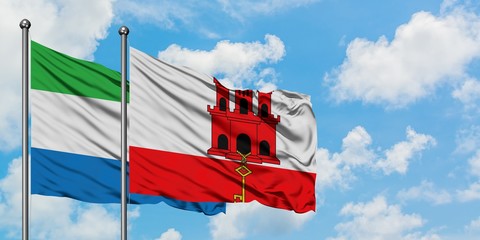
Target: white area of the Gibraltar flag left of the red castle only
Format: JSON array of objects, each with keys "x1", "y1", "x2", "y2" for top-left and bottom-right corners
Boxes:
[{"x1": 129, "y1": 48, "x2": 216, "y2": 156}]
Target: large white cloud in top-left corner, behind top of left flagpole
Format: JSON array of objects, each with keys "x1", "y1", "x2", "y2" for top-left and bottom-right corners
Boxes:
[{"x1": 0, "y1": 0, "x2": 113, "y2": 150}]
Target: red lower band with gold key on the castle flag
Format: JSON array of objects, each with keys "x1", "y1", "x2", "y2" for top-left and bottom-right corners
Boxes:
[{"x1": 130, "y1": 147, "x2": 316, "y2": 213}]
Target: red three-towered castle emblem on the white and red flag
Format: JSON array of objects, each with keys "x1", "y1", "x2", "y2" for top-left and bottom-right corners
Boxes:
[{"x1": 207, "y1": 78, "x2": 280, "y2": 164}]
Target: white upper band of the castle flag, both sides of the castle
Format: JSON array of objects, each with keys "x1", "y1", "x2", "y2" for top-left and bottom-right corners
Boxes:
[{"x1": 129, "y1": 48, "x2": 317, "y2": 172}]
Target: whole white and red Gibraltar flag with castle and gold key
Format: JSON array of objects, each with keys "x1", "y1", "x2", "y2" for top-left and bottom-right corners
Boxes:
[{"x1": 129, "y1": 48, "x2": 317, "y2": 213}]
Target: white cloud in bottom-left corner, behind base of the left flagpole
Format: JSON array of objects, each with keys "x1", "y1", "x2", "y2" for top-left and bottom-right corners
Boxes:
[{"x1": 0, "y1": 158, "x2": 120, "y2": 239}]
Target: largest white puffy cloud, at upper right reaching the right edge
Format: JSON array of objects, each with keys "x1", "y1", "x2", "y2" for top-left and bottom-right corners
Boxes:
[{"x1": 325, "y1": 8, "x2": 480, "y2": 108}]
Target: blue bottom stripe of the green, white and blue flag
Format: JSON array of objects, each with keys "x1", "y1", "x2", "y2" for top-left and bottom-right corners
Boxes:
[{"x1": 31, "y1": 148, "x2": 225, "y2": 215}]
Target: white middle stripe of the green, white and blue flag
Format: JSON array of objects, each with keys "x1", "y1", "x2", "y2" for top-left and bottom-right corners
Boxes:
[{"x1": 31, "y1": 90, "x2": 120, "y2": 159}]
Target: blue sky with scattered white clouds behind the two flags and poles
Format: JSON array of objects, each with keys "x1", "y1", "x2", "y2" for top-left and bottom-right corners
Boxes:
[{"x1": 0, "y1": 0, "x2": 480, "y2": 240}]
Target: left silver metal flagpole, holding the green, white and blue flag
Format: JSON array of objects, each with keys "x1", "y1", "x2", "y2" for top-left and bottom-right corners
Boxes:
[{"x1": 19, "y1": 19, "x2": 31, "y2": 240}]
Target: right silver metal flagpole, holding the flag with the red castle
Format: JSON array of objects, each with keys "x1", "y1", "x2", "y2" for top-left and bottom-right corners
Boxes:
[{"x1": 118, "y1": 26, "x2": 129, "y2": 240}]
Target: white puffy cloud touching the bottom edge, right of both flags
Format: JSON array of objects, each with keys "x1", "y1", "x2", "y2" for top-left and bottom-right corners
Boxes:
[{"x1": 330, "y1": 196, "x2": 439, "y2": 240}]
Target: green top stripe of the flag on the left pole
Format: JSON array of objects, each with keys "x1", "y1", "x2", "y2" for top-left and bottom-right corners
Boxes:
[{"x1": 31, "y1": 41, "x2": 128, "y2": 102}]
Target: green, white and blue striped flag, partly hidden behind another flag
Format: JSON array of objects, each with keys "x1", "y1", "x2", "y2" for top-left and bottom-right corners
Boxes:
[{"x1": 30, "y1": 41, "x2": 225, "y2": 215}]
